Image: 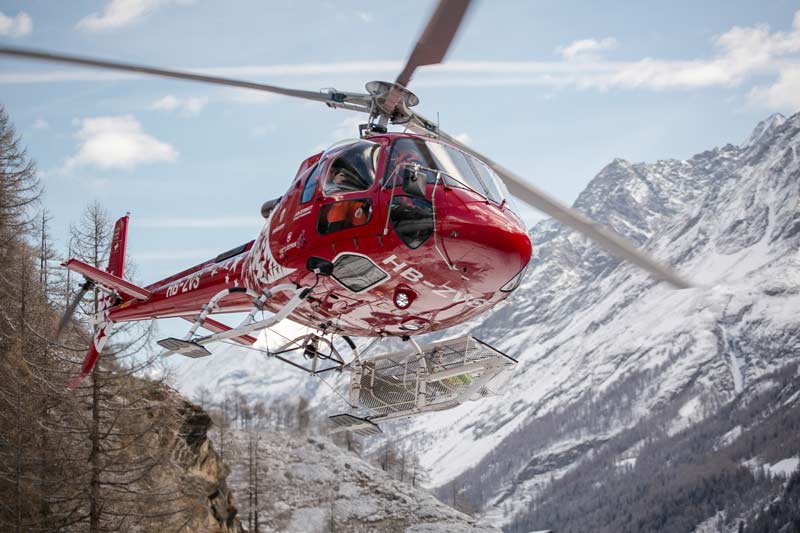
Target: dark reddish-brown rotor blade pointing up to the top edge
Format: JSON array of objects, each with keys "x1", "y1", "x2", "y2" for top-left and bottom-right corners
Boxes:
[{"x1": 395, "y1": 0, "x2": 470, "y2": 87}]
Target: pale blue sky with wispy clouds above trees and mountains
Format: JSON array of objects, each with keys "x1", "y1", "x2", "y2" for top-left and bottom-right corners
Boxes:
[{"x1": 0, "y1": 0, "x2": 800, "y2": 290}]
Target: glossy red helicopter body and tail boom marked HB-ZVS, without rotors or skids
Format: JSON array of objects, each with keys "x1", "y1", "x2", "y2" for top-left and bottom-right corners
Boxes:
[{"x1": 108, "y1": 133, "x2": 531, "y2": 336}]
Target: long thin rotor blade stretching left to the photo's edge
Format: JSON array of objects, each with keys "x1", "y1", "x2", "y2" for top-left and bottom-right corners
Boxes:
[{"x1": 0, "y1": 47, "x2": 370, "y2": 111}]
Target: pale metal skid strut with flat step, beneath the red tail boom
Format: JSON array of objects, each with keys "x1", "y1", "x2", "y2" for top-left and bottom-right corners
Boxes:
[{"x1": 157, "y1": 283, "x2": 311, "y2": 357}]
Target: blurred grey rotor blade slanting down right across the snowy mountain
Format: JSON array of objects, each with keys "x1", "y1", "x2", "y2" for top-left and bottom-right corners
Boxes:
[{"x1": 409, "y1": 114, "x2": 692, "y2": 289}]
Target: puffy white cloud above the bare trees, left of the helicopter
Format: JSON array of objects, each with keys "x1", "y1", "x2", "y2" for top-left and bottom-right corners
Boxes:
[{"x1": 64, "y1": 115, "x2": 178, "y2": 170}]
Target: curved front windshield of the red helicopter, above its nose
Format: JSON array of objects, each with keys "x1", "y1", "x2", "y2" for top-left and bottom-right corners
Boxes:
[{"x1": 384, "y1": 137, "x2": 508, "y2": 204}]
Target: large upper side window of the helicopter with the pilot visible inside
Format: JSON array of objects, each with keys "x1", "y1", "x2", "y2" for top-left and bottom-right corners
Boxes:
[{"x1": 322, "y1": 142, "x2": 380, "y2": 196}]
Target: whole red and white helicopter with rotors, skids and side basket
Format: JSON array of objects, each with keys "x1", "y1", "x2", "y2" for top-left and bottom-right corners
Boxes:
[{"x1": 0, "y1": 0, "x2": 690, "y2": 435}]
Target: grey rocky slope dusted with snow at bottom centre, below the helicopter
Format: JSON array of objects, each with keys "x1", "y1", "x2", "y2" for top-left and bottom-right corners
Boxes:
[{"x1": 222, "y1": 431, "x2": 499, "y2": 533}]
